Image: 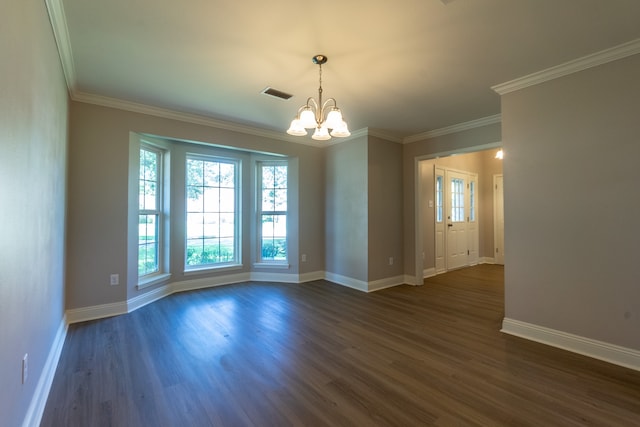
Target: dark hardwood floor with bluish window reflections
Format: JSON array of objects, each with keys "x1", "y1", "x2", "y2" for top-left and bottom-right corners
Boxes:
[{"x1": 42, "y1": 265, "x2": 640, "y2": 426}]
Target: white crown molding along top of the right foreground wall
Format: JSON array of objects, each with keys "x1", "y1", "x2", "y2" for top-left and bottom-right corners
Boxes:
[{"x1": 491, "y1": 39, "x2": 640, "y2": 95}]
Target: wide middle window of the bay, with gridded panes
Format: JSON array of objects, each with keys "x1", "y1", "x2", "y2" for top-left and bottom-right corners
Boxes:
[{"x1": 185, "y1": 155, "x2": 240, "y2": 270}]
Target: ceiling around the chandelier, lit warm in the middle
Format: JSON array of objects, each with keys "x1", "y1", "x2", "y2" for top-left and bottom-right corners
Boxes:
[{"x1": 53, "y1": 0, "x2": 640, "y2": 138}]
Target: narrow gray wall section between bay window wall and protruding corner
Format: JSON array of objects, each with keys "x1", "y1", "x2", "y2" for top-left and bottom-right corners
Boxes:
[{"x1": 325, "y1": 136, "x2": 369, "y2": 282}]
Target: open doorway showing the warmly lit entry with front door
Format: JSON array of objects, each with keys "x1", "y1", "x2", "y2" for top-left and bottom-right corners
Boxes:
[{"x1": 415, "y1": 147, "x2": 502, "y2": 284}]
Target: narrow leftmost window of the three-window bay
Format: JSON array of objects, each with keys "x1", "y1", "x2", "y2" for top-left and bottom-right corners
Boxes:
[{"x1": 138, "y1": 145, "x2": 162, "y2": 277}]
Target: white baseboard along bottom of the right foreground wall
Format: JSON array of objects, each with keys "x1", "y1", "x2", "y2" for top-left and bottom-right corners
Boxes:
[{"x1": 501, "y1": 317, "x2": 640, "y2": 371}]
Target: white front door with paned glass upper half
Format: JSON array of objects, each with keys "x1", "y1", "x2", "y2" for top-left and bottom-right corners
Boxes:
[{"x1": 445, "y1": 169, "x2": 469, "y2": 270}]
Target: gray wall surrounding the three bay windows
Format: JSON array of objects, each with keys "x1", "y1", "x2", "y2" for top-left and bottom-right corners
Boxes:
[{"x1": 66, "y1": 102, "x2": 324, "y2": 309}]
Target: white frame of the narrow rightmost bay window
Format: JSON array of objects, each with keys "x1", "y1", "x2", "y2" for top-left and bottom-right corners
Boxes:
[{"x1": 255, "y1": 159, "x2": 291, "y2": 266}]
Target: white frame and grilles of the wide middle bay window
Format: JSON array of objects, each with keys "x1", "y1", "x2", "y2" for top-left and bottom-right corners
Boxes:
[{"x1": 183, "y1": 152, "x2": 242, "y2": 273}]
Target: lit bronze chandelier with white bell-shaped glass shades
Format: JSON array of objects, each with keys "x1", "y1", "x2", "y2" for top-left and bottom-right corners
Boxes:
[{"x1": 287, "y1": 55, "x2": 351, "y2": 141}]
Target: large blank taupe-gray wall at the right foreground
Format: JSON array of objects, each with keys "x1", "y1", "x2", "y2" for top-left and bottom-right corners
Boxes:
[{"x1": 502, "y1": 55, "x2": 640, "y2": 350}]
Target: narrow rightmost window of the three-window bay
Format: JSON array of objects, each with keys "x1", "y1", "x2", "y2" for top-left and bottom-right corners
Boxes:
[{"x1": 258, "y1": 162, "x2": 287, "y2": 262}]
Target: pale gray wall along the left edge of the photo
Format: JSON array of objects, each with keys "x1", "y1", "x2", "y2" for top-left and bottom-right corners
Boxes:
[{"x1": 0, "y1": 0, "x2": 68, "y2": 426}]
